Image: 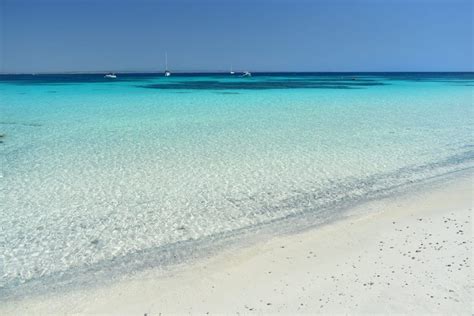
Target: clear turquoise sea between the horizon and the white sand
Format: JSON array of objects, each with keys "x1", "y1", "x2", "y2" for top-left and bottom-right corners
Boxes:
[{"x1": 0, "y1": 73, "x2": 474, "y2": 296}]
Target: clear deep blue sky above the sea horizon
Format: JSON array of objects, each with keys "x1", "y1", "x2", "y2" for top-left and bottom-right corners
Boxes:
[{"x1": 0, "y1": 0, "x2": 474, "y2": 72}]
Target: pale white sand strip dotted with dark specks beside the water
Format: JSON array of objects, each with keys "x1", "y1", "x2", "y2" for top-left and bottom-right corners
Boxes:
[{"x1": 0, "y1": 173, "x2": 474, "y2": 315}]
